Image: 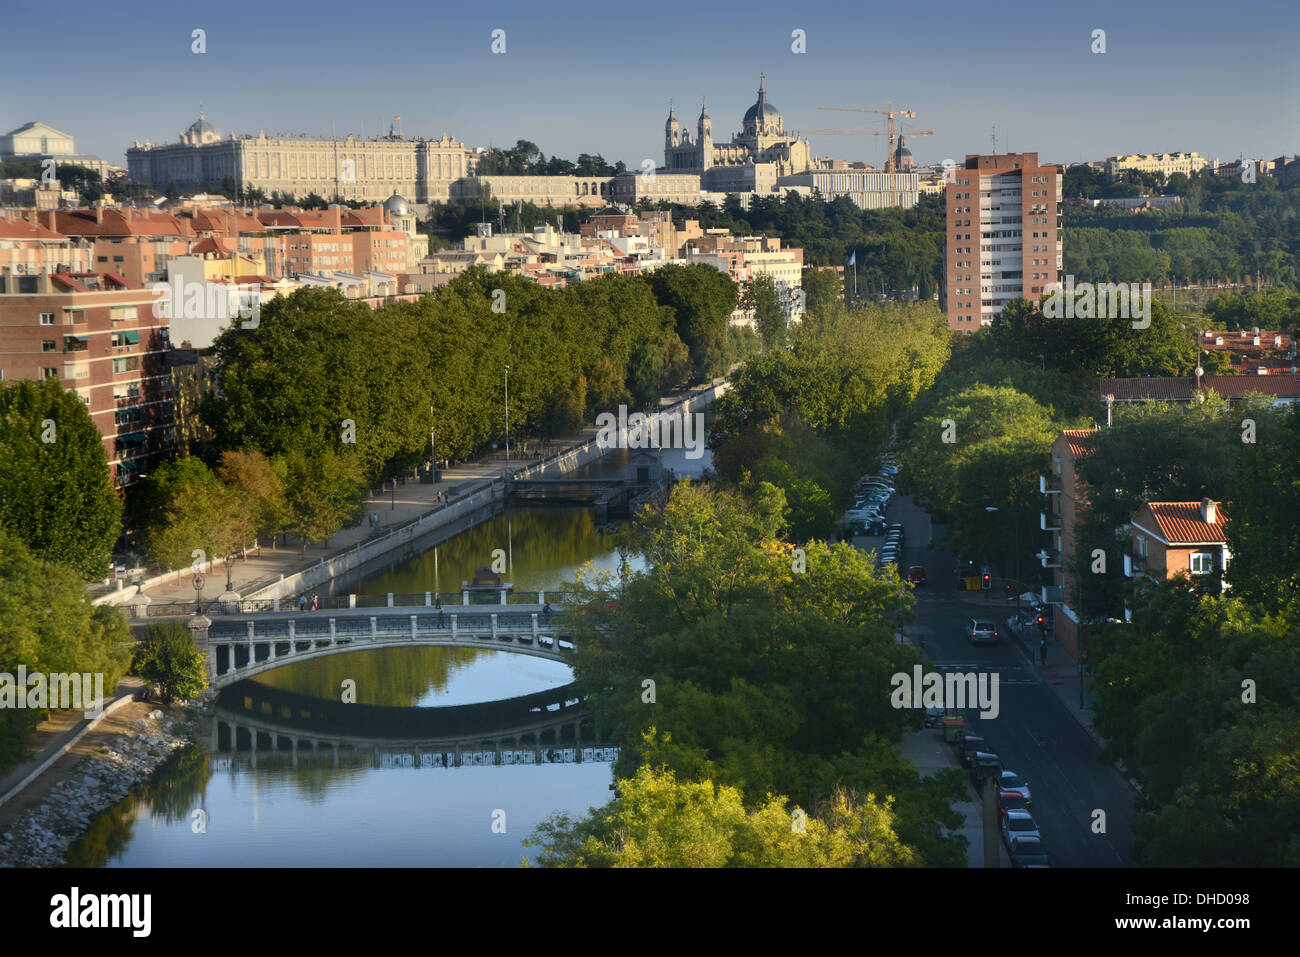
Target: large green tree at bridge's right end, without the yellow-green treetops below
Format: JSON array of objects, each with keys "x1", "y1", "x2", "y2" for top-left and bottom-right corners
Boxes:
[{"x1": 559, "y1": 484, "x2": 962, "y2": 863}]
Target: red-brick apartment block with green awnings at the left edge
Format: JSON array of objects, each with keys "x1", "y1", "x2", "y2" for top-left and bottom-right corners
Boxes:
[{"x1": 0, "y1": 272, "x2": 174, "y2": 488}]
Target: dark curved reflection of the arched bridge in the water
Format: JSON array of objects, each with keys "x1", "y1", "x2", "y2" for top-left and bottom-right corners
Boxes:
[{"x1": 208, "y1": 680, "x2": 618, "y2": 771}]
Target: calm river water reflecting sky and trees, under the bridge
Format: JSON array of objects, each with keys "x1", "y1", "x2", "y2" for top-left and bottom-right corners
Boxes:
[{"x1": 69, "y1": 436, "x2": 710, "y2": 867}]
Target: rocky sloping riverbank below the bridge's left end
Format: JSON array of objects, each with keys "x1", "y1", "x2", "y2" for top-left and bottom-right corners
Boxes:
[{"x1": 0, "y1": 709, "x2": 191, "y2": 867}]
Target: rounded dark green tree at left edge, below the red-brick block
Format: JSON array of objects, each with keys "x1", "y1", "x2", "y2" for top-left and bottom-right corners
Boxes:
[{"x1": 0, "y1": 378, "x2": 122, "y2": 580}]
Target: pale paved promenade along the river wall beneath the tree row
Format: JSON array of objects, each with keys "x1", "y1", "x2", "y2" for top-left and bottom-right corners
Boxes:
[{"x1": 115, "y1": 385, "x2": 709, "y2": 605}]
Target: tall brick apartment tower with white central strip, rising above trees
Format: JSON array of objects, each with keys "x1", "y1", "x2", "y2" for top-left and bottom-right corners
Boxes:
[{"x1": 944, "y1": 152, "x2": 1062, "y2": 333}]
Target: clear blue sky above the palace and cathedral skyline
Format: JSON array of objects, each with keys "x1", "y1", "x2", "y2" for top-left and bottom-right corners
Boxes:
[{"x1": 0, "y1": 0, "x2": 1300, "y2": 166}]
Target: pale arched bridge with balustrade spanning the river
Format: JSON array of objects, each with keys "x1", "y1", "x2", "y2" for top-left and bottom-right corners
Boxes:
[{"x1": 190, "y1": 605, "x2": 573, "y2": 689}]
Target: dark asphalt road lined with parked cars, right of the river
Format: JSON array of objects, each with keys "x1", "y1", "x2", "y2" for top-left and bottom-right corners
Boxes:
[{"x1": 857, "y1": 495, "x2": 1134, "y2": 867}]
